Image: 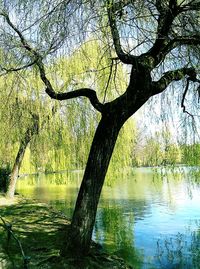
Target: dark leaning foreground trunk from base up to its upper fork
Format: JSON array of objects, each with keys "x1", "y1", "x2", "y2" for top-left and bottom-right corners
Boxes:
[{"x1": 61, "y1": 72, "x2": 150, "y2": 257}]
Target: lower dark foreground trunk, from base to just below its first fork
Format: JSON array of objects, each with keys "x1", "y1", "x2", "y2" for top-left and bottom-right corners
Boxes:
[{"x1": 61, "y1": 113, "x2": 123, "y2": 256}]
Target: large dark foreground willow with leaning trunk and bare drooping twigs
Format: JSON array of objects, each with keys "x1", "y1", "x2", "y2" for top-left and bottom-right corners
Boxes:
[{"x1": 1, "y1": 0, "x2": 200, "y2": 256}]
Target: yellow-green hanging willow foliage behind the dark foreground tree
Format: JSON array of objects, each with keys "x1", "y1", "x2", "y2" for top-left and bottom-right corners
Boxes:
[{"x1": 0, "y1": 37, "x2": 197, "y2": 176}]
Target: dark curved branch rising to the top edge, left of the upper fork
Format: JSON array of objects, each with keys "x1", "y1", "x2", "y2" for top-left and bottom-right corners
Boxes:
[{"x1": 107, "y1": 0, "x2": 138, "y2": 64}]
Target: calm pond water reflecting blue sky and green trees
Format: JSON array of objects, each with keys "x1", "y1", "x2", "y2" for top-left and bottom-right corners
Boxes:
[{"x1": 17, "y1": 168, "x2": 200, "y2": 269}]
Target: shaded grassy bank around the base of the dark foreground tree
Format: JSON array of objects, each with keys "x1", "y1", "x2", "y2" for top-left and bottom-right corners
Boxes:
[{"x1": 0, "y1": 194, "x2": 133, "y2": 269}]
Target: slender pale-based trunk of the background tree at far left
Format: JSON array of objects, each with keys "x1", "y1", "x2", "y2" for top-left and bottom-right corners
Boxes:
[{"x1": 6, "y1": 129, "x2": 31, "y2": 198}]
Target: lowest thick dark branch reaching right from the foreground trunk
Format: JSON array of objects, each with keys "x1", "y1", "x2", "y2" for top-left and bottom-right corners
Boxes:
[{"x1": 152, "y1": 67, "x2": 199, "y2": 96}]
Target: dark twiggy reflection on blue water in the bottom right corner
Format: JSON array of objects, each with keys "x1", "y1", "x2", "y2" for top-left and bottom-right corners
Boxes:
[{"x1": 155, "y1": 230, "x2": 200, "y2": 269}]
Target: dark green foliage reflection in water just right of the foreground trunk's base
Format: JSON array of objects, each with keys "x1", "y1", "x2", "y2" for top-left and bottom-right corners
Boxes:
[{"x1": 95, "y1": 206, "x2": 143, "y2": 268}]
